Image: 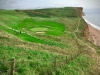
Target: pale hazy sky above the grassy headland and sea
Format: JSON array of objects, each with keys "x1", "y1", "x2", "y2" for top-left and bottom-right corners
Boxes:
[{"x1": 0, "y1": 0, "x2": 100, "y2": 9}]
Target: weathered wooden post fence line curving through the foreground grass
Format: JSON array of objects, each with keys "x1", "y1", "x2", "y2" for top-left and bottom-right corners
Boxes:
[{"x1": 1, "y1": 42, "x2": 82, "y2": 75}]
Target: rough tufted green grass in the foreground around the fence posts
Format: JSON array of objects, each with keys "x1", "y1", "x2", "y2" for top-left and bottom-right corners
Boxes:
[{"x1": 0, "y1": 46, "x2": 88, "y2": 75}]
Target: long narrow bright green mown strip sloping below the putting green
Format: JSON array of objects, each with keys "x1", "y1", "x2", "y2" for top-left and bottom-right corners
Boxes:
[{"x1": 0, "y1": 26, "x2": 70, "y2": 48}]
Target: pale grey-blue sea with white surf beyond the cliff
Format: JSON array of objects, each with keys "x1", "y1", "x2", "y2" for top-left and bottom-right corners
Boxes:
[{"x1": 83, "y1": 8, "x2": 100, "y2": 30}]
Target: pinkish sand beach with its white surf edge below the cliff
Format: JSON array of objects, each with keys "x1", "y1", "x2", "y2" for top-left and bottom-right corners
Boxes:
[{"x1": 83, "y1": 18, "x2": 100, "y2": 46}]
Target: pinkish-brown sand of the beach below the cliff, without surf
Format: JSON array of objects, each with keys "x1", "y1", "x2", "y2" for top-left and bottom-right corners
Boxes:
[{"x1": 87, "y1": 23, "x2": 100, "y2": 46}]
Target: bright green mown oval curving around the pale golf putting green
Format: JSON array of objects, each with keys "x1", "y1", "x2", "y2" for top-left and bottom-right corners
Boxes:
[{"x1": 15, "y1": 18, "x2": 64, "y2": 36}]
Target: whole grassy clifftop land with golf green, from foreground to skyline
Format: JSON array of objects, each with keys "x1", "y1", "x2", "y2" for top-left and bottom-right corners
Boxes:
[{"x1": 0, "y1": 7, "x2": 100, "y2": 75}]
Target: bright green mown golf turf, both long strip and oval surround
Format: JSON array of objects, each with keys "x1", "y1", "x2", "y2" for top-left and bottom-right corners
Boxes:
[{"x1": 1, "y1": 9, "x2": 77, "y2": 47}]
